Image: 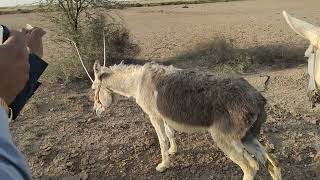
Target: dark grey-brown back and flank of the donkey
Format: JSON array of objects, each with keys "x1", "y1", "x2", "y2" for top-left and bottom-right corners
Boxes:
[{"x1": 141, "y1": 65, "x2": 266, "y2": 135}]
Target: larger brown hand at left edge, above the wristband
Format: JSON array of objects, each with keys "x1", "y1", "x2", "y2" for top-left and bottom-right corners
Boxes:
[{"x1": 0, "y1": 31, "x2": 29, "y2": 105}]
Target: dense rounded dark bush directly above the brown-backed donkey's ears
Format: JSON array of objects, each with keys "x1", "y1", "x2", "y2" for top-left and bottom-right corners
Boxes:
[{"x1": 81, "y1": 14, "x2": 139, "y2": 67}]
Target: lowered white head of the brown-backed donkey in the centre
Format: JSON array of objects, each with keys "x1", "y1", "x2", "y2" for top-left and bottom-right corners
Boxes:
[{"x1": 92, "y1": 61, "x2": 112, "y2": 116}]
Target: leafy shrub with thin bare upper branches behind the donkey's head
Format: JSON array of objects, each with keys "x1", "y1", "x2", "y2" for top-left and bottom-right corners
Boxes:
[{"x1": 42, "y1": 0, "x2": 139, "y2": 83}]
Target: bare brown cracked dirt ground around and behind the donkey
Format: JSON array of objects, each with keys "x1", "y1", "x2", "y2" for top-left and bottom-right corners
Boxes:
[{"x1": 0, "y1": 0, "x2": 320, "y2": 180}]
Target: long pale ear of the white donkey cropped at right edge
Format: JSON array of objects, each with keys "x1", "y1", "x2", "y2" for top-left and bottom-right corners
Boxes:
[{"x1": 282, "y1": 11, "x2": 320, "y2": 46}]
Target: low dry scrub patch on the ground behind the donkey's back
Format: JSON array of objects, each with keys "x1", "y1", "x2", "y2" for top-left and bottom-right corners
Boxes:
[{"x1": 167, "y1": 37, "x2": 305, "y2": 73}]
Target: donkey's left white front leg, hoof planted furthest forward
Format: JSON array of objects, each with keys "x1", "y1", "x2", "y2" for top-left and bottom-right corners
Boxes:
[{"x1": 150, "y1": 116, "x2": 170, "y2": 172}]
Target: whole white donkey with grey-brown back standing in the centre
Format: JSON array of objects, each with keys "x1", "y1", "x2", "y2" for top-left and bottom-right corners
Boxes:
[{"x1": 92, "y1": 62, "x2": 281, "y2": 180}]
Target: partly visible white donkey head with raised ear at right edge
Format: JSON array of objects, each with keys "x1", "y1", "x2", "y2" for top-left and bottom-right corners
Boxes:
[{"x1": 283, "y1": 11, "x2": 320, "y2": 104}]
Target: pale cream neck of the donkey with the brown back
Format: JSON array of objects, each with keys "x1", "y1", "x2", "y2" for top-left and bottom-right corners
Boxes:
[{"x1": 102, "y1": 65, "x2": 142, "y2": 97}]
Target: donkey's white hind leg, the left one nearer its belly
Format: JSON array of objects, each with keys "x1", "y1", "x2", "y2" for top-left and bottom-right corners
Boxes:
[{"x1": 210, "y1": 130, "x2": 259, "y2": 180}]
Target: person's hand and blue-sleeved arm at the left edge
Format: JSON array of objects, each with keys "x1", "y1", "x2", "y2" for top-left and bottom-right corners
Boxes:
[{"x1": 0, "y1": 28, "x2": 31, "y2": 180}]
